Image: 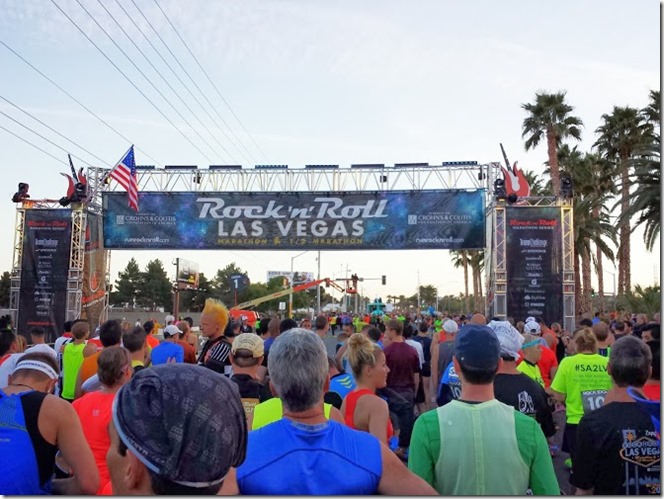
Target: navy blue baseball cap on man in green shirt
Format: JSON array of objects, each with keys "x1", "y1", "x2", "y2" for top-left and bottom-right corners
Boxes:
[{"x1": 454, "y1": 324, "x2": 500, "y2": 369}]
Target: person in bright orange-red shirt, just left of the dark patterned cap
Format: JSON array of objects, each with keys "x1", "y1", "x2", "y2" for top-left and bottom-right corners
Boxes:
[{"x1": 72, "y1": 346, "x2": 132, "y2": 495}]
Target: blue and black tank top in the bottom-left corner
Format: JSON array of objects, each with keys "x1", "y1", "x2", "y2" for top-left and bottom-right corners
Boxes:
[{"x1": 0, "y1": 391, "x2": 57, "y2": 495}]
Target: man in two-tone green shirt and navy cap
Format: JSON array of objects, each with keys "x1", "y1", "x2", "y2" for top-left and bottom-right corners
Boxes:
[{"x1": 408, "y1": 324, "x2": 560, "y2": 495}]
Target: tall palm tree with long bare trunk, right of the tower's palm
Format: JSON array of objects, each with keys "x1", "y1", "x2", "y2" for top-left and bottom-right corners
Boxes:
[{"x1": 594, "y1": 106, "x2": 647, "y2": 294}]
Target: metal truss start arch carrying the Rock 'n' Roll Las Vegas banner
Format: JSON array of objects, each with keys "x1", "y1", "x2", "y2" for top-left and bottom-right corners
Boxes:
[{"x1": 10, "y1": 161, "x2": 574, "y2": 342}]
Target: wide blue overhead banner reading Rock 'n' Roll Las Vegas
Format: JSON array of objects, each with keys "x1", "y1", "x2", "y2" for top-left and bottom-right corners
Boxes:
[{"x1": 103, "y1": 190, "x2": 485, "y2": 250}]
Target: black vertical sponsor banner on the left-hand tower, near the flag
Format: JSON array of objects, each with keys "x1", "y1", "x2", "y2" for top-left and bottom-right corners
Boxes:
[{"x1": 18, "y1": 209, "x2": 71, "y2": 342}]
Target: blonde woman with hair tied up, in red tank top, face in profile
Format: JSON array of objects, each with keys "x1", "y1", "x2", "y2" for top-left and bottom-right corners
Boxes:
[{"x1": 341, "y1": 333, "x2": 394, "y2": 445}]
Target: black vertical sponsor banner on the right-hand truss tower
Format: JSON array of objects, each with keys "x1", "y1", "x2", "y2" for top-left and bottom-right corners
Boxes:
[{"x1": 505, "y1": 206, "x2": 563, "y2": 325}]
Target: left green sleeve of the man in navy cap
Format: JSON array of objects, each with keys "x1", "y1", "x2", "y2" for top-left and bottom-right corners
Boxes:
[{"x1": 408, "y1": 411, "x2": 440, "y2": 487}]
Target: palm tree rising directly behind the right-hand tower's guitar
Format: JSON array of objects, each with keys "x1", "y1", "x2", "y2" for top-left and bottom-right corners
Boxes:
[{"x1": 521, "y1": 92, "x2": 583, "y2": 196}]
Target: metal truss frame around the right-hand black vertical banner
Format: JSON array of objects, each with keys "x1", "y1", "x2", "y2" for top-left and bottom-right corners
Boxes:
[{"x1": 486, "y1": 196, "x2": 576, "y2": 331}]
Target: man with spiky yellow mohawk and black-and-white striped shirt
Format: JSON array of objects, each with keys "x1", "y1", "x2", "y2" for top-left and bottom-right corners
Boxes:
[{"x1": 198, "y1": 298, "x2": 231, "y2": 376}]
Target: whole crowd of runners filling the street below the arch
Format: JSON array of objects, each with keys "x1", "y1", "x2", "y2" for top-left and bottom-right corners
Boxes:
[{"x1": 0, "y1": 299, "x2": 661, "y2": 495}]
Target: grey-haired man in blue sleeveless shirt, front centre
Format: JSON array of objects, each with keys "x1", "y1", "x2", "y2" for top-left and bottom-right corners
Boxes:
[{"x1": 226, "y1": 328, "x2": 435, "y2": 495}]
